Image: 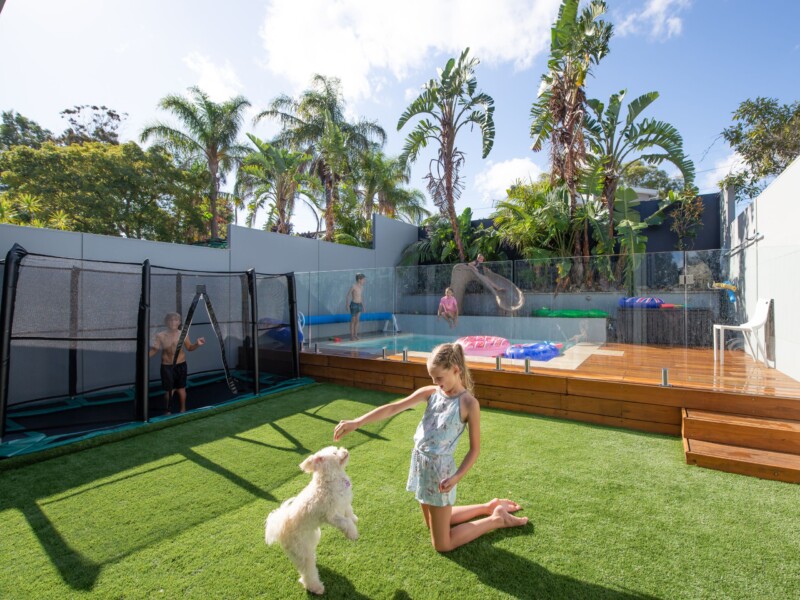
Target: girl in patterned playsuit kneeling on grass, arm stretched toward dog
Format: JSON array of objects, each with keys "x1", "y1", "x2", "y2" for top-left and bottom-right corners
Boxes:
[{"x1": 333, "y1": 344, "x2": 528, "y2": 552}]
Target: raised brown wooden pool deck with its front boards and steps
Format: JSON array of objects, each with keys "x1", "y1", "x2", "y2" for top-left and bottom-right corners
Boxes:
[{"x1": 300, "y1": 344, "x2": 800, "y2": 481}]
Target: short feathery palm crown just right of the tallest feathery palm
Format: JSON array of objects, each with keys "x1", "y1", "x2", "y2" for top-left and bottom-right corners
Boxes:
[{"x1": 358, "y1": 150, "x2": 430, "y2": 224}]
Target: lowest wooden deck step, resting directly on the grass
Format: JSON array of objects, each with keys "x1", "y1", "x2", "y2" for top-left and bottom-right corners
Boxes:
[{"x1": 683, "y1": 438, "x2": 800, "y2": 483}]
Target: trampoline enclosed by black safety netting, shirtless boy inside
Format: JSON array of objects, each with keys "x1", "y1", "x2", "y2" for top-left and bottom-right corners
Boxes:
[{"x1": 0, "y1": 245, "x2": 299, "y2": 457}]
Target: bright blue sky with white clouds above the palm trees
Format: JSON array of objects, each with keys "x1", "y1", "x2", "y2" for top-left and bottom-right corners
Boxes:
[{"x1": 0, "y1": 0, "x2": 800, "y2": 231}]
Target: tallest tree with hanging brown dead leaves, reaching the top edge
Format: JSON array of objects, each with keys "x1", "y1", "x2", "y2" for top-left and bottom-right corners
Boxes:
[{"x1": 530, "y1": 0, "x2": 613, "y2": 223}]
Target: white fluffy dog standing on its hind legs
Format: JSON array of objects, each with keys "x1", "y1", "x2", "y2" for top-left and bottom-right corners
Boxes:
[{"x1": 264, "y1": 446, "x2": 358, "y2": 594}]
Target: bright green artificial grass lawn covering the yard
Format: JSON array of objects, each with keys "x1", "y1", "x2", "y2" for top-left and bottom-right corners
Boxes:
[{"x1": 0, "y1": 385, "x2": 800, "y2": 600}]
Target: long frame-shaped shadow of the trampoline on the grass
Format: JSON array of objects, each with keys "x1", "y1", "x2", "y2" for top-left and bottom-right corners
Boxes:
[{"x1": 0, "y1": 385, "x2": 396, "y2": 598}]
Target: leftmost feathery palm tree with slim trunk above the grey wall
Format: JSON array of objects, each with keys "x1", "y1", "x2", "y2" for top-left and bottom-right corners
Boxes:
[{"x1": 141, "y1": 87, "x2": 250, "y2": 238}]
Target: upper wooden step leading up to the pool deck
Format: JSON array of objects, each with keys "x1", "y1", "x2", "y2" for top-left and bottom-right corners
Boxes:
[{"x1": 683, "y1": 409, "x2": 800, "y2": 455}]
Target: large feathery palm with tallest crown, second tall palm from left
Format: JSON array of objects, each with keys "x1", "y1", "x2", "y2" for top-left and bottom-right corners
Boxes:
[{"x1": 254, "y1": 75, "x2": 386, "y2": 241}]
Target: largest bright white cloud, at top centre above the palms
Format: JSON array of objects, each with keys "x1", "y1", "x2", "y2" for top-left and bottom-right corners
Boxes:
[{"x1": 260, "y1": 0, "x2": 560, "y2": 99}]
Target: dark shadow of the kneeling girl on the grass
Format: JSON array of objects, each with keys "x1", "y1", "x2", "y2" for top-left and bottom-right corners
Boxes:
[{"x1": 443, "y1": 523, "x2": 656, "y2": 600}]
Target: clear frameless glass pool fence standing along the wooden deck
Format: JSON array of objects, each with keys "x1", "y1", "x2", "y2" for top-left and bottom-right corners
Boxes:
[{"x1": 297, "y1": 248, "x2": 800, "y2": 394}]
